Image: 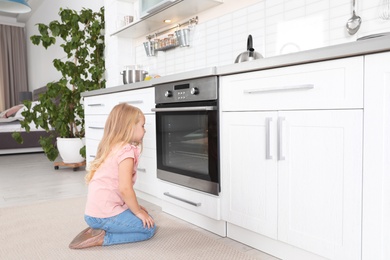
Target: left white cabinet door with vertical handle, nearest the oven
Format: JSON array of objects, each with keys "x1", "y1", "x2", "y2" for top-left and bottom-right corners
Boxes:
[{"x1": 221, "y1": 112, "x2": 277, "y2": 238}]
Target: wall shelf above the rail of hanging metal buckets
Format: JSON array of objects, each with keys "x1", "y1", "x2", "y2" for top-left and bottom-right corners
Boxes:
[{"x1": 111, "y1": 0, "x2": 223, "y2": 39}]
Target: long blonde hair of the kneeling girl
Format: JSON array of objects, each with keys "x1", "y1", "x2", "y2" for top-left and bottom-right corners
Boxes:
[{"x1": 85, "y1": 103, "x2": 142, "y2": 183}]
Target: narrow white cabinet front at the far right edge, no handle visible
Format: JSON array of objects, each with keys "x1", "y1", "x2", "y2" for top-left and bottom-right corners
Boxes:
[{"x1": 362, "y1": 52, "x2": 390, "y2": 260}]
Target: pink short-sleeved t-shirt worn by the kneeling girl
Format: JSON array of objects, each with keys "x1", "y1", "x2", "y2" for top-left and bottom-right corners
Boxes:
[{"x1": 85, "y1": 144, "x2": 140, "y2": 218}]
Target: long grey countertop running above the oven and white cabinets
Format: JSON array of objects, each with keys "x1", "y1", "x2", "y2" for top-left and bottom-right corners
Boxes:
[{"x1": 82, "y1": 35, "x2": 390, "y2": 97}]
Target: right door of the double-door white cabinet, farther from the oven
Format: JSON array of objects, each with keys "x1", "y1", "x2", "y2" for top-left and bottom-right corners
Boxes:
[{"x1": 278, "y1": 110, "x2": 363, "y2": 260}]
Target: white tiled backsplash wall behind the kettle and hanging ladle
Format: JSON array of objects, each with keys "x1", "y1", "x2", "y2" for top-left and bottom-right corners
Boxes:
[{"x1": 105, "y1": 0, "x2": 390, "y2": 86}]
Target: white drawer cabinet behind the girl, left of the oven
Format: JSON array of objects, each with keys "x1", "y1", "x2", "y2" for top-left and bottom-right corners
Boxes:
[{"x1": 84, "y1": 88, "x2": 159, "y2": 197}]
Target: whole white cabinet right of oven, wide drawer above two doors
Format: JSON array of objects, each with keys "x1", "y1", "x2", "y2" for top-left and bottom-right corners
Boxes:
[{"x1": 220, "y1": 57, "x2": 363, "y2": 260}]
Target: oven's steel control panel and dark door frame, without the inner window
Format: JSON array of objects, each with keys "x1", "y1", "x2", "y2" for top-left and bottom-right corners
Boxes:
[{"x1": 153, "y1": 77, "x2": 221, "y2": 195}]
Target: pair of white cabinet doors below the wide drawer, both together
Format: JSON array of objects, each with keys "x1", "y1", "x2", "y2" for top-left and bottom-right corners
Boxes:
[{"x1": 222, "y1": 110, "x2": 362, "y2": 260}]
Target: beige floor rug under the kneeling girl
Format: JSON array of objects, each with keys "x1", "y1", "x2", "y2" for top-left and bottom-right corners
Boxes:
[{"x1": 0, "y1": 198, "x2": 253, "y2": 260}]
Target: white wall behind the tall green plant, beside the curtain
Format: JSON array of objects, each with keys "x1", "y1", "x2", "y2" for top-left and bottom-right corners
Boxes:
[{"x1": 25, "y1": 0, "x2": 104, "y2": 90}]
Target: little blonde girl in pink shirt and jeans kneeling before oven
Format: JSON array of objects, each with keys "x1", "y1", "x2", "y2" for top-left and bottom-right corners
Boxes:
[{"x1": 69, "y1": 103, "x2": 156, "y2": 249}]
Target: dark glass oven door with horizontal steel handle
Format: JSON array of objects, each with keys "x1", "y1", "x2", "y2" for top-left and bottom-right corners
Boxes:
[{"x1": 156, "y1": 101, "x2": 219, "y2": 193}]
